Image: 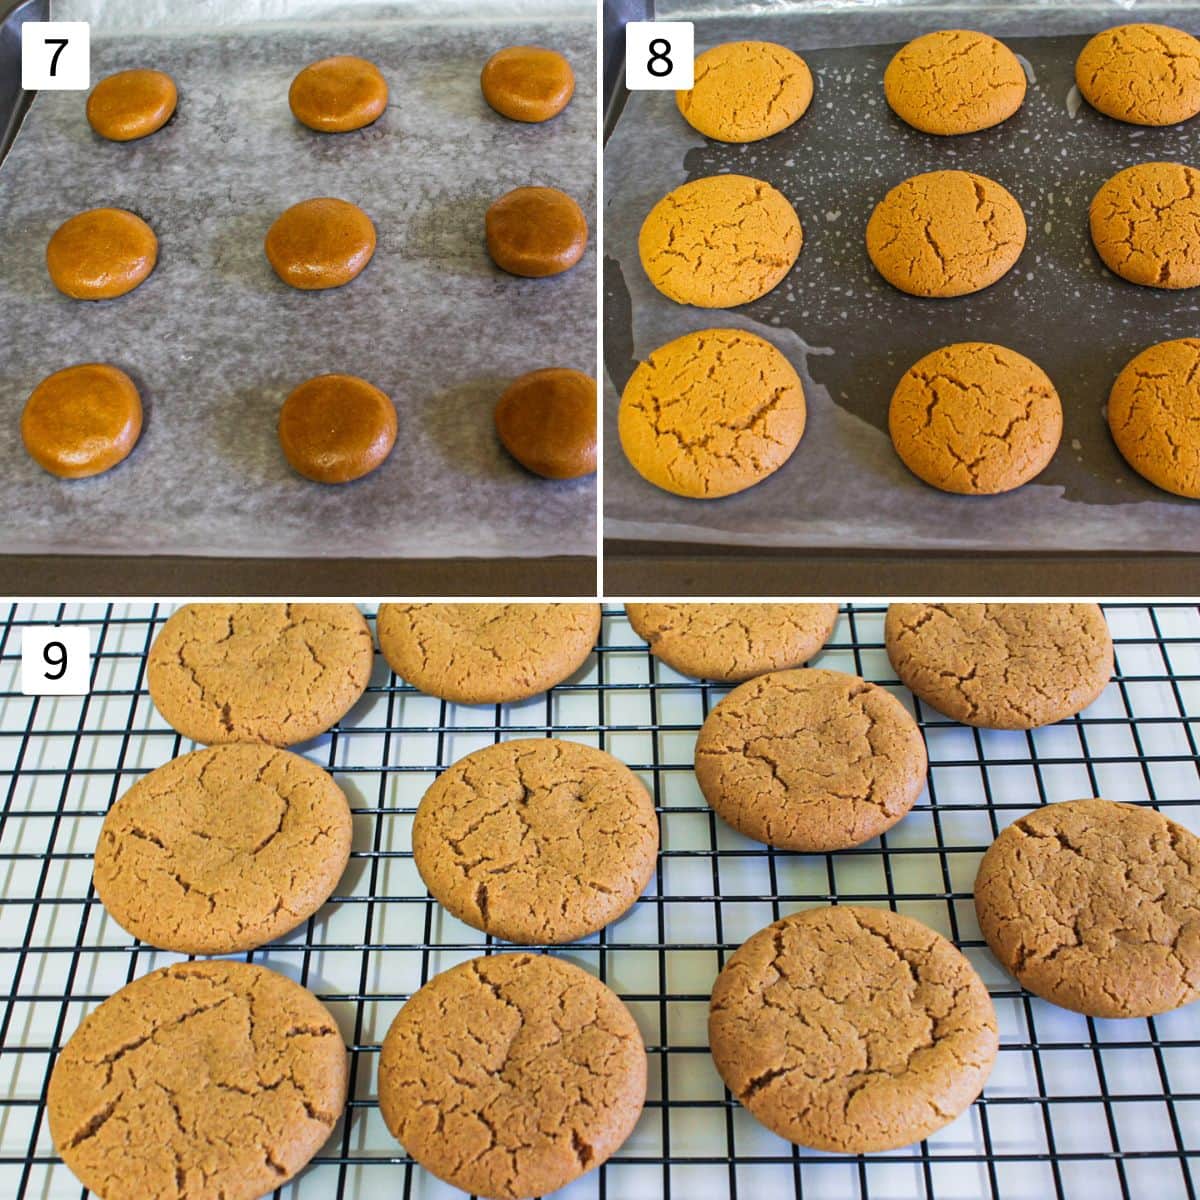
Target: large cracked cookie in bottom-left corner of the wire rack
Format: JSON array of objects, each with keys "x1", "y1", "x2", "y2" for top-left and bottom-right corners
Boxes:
[{"x1": 46, "y1": 962, "x2": 349, "y2": 1200}]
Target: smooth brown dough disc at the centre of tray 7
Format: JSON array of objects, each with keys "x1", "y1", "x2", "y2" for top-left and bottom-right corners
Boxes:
[{"x1": 266, "y1": 197, "x2": 376, "y2": 292}]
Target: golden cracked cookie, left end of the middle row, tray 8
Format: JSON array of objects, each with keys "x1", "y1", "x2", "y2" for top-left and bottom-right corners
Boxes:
[{"x1": 637, "y1": 175, "x2": 804, "y2": 308}]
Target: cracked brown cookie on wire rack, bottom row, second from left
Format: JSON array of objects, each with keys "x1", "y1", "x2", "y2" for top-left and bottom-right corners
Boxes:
[{"x1": 379, "y1": 954, "x2": 646, "y2": 1200}]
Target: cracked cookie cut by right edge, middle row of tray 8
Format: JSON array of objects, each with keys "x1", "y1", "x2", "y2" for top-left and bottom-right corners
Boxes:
[{"x1": 1088, "y1": 162, "x2": 1200, "y2": 288}]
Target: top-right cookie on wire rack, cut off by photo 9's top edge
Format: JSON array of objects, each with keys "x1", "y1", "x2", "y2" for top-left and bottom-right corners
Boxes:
[{"x1": 883, "y1": 604, "x2": 1112, "y2": 730}]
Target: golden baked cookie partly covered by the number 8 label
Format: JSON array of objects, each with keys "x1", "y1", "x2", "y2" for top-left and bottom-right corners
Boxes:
[{"x1": 676, "y1": 42, "x2": 812, "y2": 142}]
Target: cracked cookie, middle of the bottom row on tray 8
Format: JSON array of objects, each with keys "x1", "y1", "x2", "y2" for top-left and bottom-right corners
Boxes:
[{"x1": 888, "y1": 342, "x2": 1062, "y2": 496}]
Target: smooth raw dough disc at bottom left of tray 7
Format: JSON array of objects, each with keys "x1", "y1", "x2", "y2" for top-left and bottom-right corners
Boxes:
[{"x1": 20, "y1": 362, "x2": 142, "y2": 479}]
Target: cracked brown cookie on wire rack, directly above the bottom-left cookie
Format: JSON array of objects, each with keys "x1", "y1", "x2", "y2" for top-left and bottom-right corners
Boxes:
[{"x1": 94, "y1": 744, "x2": 350, "y2": 954}]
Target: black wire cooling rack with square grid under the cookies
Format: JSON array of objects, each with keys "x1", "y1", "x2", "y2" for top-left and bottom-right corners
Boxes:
[{"x1": 0, "y1": 605, "x2": 1200, "y2": 1200}]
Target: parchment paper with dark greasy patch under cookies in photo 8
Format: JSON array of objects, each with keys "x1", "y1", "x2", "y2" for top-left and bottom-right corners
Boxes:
[{"x1": 605, "y1": 2, "x2": 1200, "y2": 552}]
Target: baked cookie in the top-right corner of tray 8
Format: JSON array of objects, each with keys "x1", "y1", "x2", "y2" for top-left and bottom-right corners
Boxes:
[{"x1": 1075, "y1": 25, "x2": 1200, "y2": 125}]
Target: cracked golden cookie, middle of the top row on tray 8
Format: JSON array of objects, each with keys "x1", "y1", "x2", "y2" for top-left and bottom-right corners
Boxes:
[{"x1": 883, "y1": 29, "x2": 1025, "y2": 136}]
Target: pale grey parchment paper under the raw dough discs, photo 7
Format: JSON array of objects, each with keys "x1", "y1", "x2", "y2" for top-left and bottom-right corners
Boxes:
[{"x1": 0, "y1": 0, "x2": 595, "y2": 558}]
